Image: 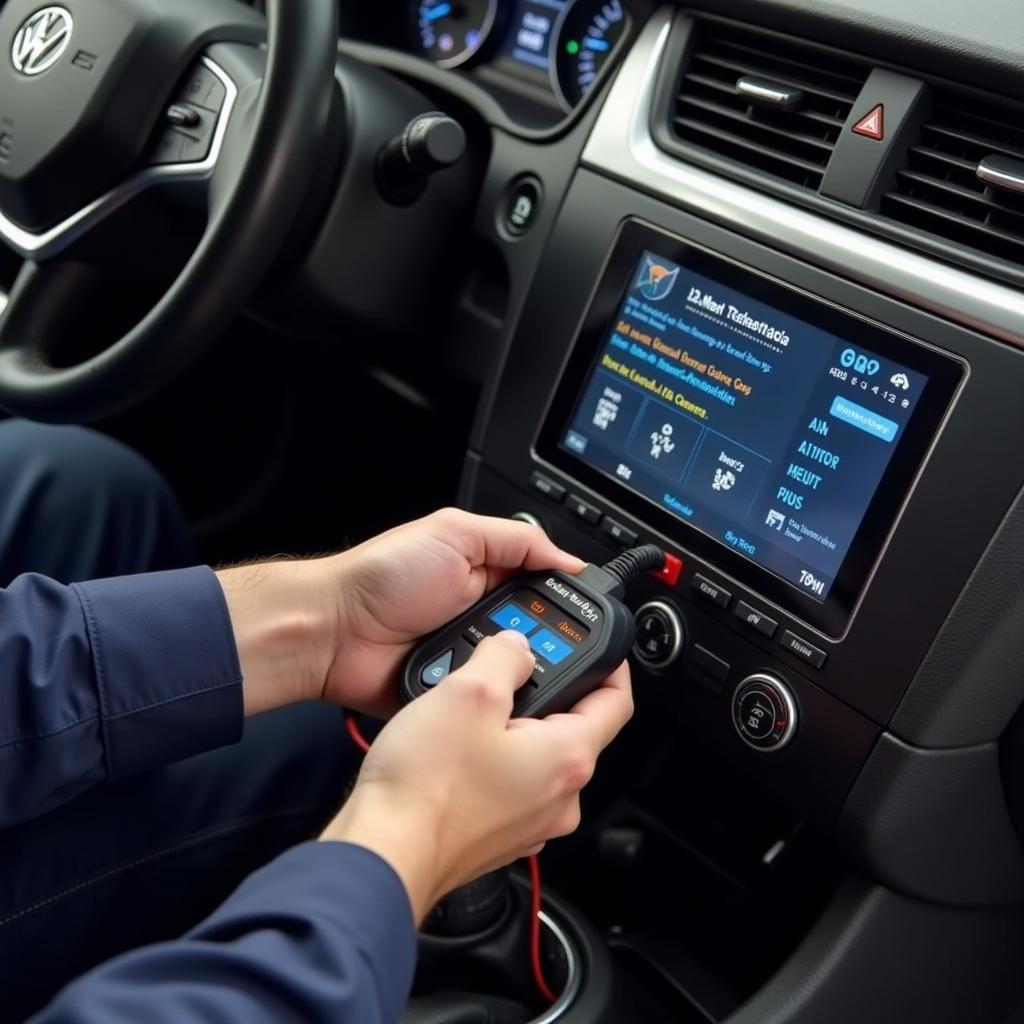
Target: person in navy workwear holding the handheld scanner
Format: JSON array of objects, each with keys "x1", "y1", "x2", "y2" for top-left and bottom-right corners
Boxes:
[{"x1": 0, "y1": 425, "x2": 632, "y2": 1024}]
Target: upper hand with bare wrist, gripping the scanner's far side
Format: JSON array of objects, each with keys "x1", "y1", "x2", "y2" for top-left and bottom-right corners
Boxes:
[{"x1": 218, "y1": 509, "x2": 584, "y2": 716}]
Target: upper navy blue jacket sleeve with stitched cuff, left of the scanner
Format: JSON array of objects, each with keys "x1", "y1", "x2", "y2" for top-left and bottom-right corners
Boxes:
[{"x1": 0, "y1": 567, "x2": 243, "y2": 827}]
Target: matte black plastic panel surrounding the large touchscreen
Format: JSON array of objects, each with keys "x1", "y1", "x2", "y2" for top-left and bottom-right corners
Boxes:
[{"x1": 468, "y1": 172, "x2": 1024, "y2": 723}]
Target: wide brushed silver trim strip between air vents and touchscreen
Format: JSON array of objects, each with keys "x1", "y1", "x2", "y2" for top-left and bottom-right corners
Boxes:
[{"x1": 583, "y1": 7, "x2": 1024, "y2": 348}]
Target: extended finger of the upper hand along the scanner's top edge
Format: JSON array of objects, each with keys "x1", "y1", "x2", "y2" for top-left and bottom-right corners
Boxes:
[{"x1": 437, "y1": 509, "x2": 585, "y2": 573}]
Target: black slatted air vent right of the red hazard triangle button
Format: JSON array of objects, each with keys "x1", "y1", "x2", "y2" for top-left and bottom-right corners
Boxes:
[{"x1": 882, "y1": 92, "x2": 1024, "y2": 263}]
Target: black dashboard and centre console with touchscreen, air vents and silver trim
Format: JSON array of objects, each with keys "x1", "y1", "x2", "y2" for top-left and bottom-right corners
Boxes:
[{"x1": 230, "y1": 0, "x2": 1024, "y2": 1024}]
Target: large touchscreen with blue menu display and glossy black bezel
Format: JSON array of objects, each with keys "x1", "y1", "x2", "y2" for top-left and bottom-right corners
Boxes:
[{"x1": 550, "y1": 224, "x2": 963, "y2": 625}]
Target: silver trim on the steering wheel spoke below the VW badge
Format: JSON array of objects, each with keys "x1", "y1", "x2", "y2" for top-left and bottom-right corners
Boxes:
[{"x1": 0, "y1": 57, "x2": 239, "y2": 261}]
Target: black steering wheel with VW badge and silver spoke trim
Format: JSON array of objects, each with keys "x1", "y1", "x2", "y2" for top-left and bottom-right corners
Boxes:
[{"x1": 0, "y1": 0, "x2": 338, "y2": 422}]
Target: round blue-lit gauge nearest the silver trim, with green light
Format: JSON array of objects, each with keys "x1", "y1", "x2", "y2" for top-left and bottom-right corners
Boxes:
[{"x1": 550, "y1": 0, "x2": 629, "y2": 111}]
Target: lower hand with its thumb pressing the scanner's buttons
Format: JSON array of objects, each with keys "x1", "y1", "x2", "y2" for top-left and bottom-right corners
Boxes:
[{"x1": 322, "y1": 633, "x2": 633, "y2": 921}]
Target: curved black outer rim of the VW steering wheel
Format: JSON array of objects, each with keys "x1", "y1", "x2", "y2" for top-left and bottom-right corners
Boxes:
[{"x1": 0, "y1": 0, "x2": 338, "y2": 423}]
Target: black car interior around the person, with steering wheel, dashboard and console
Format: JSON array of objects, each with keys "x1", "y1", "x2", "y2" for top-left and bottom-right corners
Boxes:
[{"x1": 6, "y1": 0, "x2": 1024, "y2": 1024}]
